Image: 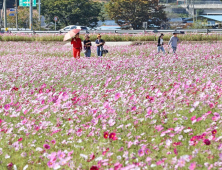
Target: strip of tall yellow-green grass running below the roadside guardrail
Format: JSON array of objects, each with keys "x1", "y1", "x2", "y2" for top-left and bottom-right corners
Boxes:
[{"x1": 0, "y1": 33, "x2": 222, "y2": 41}]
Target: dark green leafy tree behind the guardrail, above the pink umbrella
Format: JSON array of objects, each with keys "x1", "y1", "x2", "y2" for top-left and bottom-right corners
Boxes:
[{"x1": 41, "y1": 0, "x2": 101, "y2": 27}]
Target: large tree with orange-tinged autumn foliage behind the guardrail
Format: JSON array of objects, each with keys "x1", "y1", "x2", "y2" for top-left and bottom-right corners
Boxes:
[{"x1": 106, "y1": 0, "x2": 167, "y2": 29}]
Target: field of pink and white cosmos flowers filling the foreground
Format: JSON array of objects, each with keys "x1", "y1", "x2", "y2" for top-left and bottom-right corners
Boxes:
[{"x1": 0, "y1": 42, "x2": 222, "y2": 170}]
